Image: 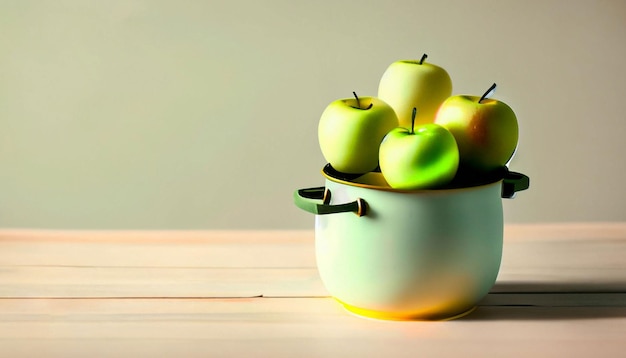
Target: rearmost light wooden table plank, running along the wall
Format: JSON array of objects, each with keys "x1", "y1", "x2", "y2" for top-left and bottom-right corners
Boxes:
[{"x1": 0, "y1": 223, "x2": 626, "y2": 267}]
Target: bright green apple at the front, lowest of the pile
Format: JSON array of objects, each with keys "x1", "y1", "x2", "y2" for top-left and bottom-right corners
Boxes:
[{"x1": 379, "y1": 123, "x2": 459, "y2": 190}]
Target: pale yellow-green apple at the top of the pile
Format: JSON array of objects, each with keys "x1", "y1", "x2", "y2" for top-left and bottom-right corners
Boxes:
[{"x1": 378, "y1": 54, "x2": 452, "y2": 128}]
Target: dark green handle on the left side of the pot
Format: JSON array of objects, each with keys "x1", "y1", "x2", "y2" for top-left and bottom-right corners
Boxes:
[{"x1": 293, "y1": 186, "x2": 367, "y2": 216}]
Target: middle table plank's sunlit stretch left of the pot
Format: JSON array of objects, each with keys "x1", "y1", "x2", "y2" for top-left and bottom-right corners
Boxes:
[{"x1": 0, "y1": 266, "x2": 328, "y2": 298}]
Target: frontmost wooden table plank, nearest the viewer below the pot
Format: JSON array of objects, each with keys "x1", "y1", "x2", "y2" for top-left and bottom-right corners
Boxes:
[{"x1": 0, "y1": 298, "x2": 626, "y2": 357}]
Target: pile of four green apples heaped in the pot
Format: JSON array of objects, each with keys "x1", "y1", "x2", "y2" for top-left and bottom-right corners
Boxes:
[{"x1": 318, "y1": 54, "x2": 519, "y2": 190}]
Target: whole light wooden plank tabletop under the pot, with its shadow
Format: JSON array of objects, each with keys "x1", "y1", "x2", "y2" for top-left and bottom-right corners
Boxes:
[{"x1": 0, "y1": 223, "x2": 626, "y2": 358}]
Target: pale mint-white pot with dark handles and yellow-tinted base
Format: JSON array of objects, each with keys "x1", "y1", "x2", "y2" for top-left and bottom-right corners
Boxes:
[{"x1": 294, "y1": 166, "x2": 529, "y2": 319}]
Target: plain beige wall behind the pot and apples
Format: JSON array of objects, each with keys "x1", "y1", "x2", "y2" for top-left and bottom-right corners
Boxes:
[{"x1": 0, "y1": 0, "x2": 626, "y2": 229}]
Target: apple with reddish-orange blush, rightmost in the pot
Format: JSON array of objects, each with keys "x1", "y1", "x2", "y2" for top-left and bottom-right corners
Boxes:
[{"x1": 435, "y1": 95, "x2": 519, "y2": 171}]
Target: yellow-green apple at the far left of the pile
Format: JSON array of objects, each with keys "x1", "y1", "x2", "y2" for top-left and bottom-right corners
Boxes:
[{"x1": 318, "y1": 97, "x2": 398, "y2": 174}]
